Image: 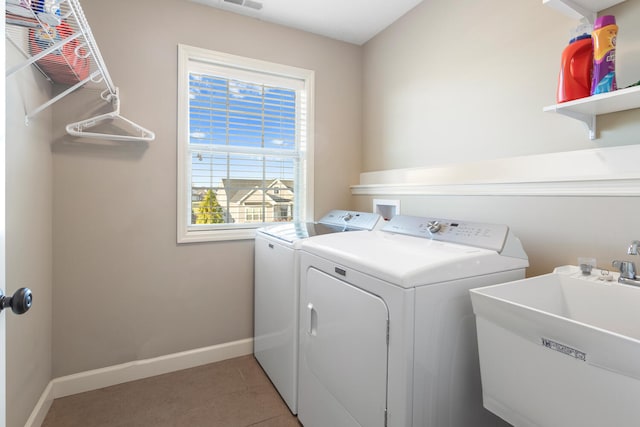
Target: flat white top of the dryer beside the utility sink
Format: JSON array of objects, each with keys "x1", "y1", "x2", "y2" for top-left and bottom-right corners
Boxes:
[{"x1": 301, "y1": 220, "x2": 529, "y2": 288}]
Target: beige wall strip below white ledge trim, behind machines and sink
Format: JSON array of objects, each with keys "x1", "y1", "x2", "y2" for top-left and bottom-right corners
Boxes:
[{"x1": 355, "y1": 196, "x2": 640, "y2": 276}]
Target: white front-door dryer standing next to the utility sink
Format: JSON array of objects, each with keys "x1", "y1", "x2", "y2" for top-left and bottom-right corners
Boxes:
[{"x1": 298, "y1": 216, "x2": 528, "y2": 427}]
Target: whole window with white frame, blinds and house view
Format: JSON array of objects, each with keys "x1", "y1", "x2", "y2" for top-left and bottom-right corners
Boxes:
[{"x1": 177, "y1": 45, "x2": 314, "y2": 243}]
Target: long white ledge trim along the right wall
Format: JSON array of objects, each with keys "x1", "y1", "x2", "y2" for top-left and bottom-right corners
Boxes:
[{"x1": 351, "y1": 145, "x2": 640, "y2": 197}]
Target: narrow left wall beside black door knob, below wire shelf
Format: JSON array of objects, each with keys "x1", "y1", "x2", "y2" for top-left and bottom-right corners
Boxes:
[{"x1": 3, "y1": 38, "x2": 53, "y2": 427}]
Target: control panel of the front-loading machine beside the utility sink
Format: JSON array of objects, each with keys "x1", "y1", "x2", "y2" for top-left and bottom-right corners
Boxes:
[{"x1": 382, "y1": 215, "x2": 509, "y2": 252}]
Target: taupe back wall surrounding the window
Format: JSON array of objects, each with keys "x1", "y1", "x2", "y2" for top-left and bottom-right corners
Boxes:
[{"x1": 53, "y1": 0, "x2": 362, "y2": 376}]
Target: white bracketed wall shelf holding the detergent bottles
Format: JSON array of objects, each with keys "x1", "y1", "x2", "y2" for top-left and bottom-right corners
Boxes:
[{"x1": 543, "y1": 86, "x2": 640, "y2": 139}]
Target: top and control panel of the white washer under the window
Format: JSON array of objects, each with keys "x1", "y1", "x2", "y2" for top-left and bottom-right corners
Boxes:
[{"x1": 258, "y1": 210, "x2": 381, "y2": 243}]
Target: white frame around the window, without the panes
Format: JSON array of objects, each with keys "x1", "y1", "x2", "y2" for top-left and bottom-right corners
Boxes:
[{"x1": 177, "y1": 44, "x2": 315, "y2": 243}]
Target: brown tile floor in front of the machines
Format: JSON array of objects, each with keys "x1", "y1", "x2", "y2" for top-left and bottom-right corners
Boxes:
[{"x1": 42, "y1": 356, "x2": 300, "y2": 427}]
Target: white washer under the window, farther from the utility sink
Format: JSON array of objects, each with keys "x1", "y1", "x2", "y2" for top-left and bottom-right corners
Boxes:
[{"x1": 254, "y1": 210, "x2": 381, "y2": 414}]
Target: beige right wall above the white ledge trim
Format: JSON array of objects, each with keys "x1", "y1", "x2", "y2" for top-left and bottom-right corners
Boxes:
[{"x1": 363, "y1": 0, "x2": 640, "y2": 171}]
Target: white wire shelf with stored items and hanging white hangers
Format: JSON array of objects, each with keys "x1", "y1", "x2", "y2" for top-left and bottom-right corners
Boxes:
[{"x1": 6, "y1": 0, "x2": 155, "y2": 141}]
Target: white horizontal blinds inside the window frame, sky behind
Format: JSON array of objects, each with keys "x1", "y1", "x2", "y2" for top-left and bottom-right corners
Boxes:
[{"x1": 189, "y1": 65, "x2": 306, "y2": 227}]
